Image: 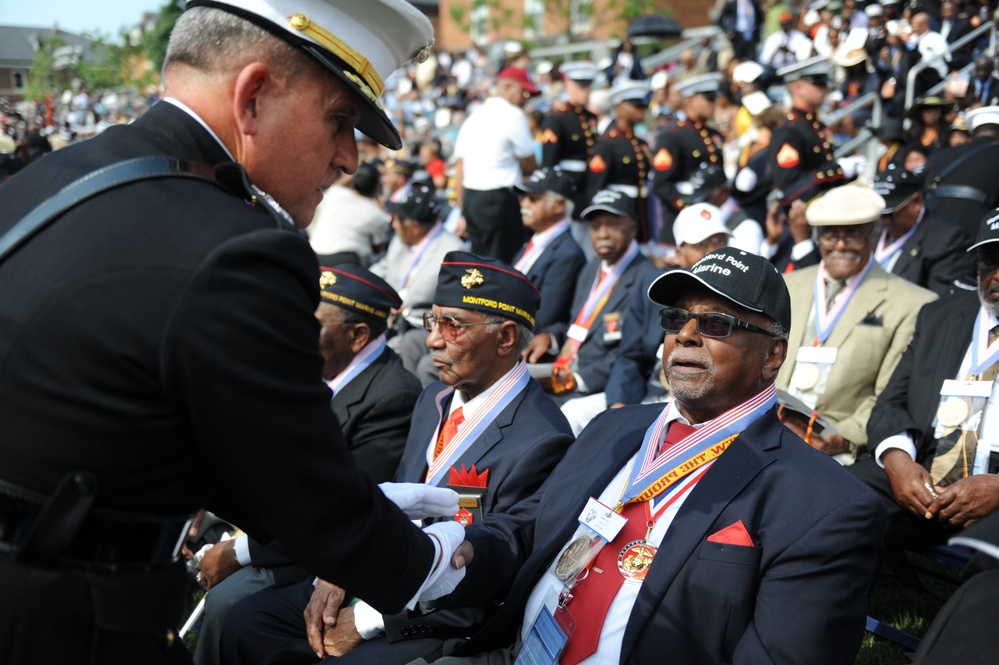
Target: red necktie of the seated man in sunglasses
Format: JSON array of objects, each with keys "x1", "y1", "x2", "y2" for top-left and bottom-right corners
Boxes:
[{"x1": 559, "y1": 420, "x2": 694, "y2": 665}]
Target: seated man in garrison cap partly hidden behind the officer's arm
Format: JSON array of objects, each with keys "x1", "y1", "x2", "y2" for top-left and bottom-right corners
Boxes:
[{"x1": 194, "y1": 263, "x2": 421, "y2": 665}]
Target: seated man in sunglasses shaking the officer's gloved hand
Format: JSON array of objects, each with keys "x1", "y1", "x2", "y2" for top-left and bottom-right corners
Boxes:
[{"x1": 412, "y1": 247, "x2": 885, "y2": 665}]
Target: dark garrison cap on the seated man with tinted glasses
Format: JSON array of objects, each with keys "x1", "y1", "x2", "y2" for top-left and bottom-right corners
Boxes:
[{"x1": 434, "y1": 252, "x2": 541, "y2": 328}]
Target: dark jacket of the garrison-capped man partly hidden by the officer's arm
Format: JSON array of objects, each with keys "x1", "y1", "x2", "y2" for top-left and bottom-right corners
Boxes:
[{"x1": 249, "y1": 347, "x2": 423, "y2": 584}]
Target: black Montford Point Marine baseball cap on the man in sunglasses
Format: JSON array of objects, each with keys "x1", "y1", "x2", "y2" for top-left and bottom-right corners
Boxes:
[{"x1": 648, "y1": 247, "x2": 791, "y2": 331}]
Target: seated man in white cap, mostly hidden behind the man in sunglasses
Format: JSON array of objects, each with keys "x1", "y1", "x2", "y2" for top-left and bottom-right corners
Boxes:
[{"x1": 562, "y1": 203, "x2": 731, "y2": 436}]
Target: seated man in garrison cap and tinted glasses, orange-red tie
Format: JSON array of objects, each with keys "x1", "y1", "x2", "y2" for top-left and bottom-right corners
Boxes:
[{"x1": 222, "y1": 252, "x2": 572, "y2": 665}]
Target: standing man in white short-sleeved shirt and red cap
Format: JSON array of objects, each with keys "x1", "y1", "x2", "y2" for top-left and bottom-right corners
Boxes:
[{"x1": 454, "y1": 67, "x2": 540, "y2": 261}]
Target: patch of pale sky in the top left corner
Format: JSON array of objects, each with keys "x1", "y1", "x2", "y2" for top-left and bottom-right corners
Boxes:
[{"x1": 0, "y1": 0, "x2": 163, "y2": 37}]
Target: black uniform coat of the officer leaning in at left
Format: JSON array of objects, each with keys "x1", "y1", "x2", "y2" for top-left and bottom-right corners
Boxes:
[{"x1": 0, "y1": 102, "x2": 433, "y2": 611}]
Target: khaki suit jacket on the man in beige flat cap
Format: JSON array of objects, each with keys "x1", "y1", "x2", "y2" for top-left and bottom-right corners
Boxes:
[{"x1": 777, "y1": 263, "x2": 937, "y2": 445}]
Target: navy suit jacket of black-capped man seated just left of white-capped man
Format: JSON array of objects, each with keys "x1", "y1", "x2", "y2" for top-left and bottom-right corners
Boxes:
[{"x1": 547, "y1": 253, "x2": 657, "y2": 393}]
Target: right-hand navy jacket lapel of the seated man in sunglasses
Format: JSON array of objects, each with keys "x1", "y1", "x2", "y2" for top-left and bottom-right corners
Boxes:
[{"x1": 621, "y1": 410, "x2": 782, "y2": 662}]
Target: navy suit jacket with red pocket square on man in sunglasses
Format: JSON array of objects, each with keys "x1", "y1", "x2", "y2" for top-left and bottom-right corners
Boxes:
[{"x1": 452, "y1": 405, "x2": 885, "y2": 665}]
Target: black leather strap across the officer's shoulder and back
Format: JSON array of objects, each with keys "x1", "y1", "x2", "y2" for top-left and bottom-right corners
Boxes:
[{"x1": 0, "y1": 156, "x2": 222, "y2": 262}]
